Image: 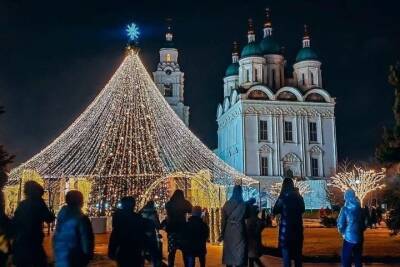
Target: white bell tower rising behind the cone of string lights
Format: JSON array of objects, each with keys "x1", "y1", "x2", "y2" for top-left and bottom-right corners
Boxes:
[{"x1": 153, "y1": 27, "x2": 189, "y2": 126}]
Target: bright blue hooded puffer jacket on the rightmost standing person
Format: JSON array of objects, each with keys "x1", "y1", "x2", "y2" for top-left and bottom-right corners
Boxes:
[{"x1": 337, "y1": 189, "x2": 366, "y2": 244}]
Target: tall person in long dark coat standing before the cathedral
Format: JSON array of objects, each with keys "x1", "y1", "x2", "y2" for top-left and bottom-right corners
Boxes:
[{"x1": 273, "y1": 178, "x2": 305, "y2": 267}]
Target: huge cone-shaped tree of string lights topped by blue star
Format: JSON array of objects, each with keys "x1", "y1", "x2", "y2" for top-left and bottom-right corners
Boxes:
[{"x1": 10, "y1": 24, "x2": 253, "y2": 215}]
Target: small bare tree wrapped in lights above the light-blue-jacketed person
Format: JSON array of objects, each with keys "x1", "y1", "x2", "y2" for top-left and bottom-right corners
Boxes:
[{"x1": 329, "y1": 166, "x2": 386, "y2": 204}]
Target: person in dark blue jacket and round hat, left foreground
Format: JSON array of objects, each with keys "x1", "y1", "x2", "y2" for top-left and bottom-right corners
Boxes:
[{"x1": 53, "y1": 190, "x2": 94, "y2": 267}]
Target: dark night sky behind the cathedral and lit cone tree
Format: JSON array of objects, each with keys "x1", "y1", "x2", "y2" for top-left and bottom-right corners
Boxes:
[{"x1": 0, "y1": 0, "x2": 400, "y2": 165}]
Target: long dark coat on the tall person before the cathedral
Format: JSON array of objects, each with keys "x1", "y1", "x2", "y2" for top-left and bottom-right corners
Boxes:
[{"x1": 273, "y1": 191, "x2": 305, "y2": 249}]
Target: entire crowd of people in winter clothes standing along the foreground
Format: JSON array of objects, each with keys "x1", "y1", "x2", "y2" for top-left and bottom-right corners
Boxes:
[{"x1": 0, "y1": 178, "x2": 372, "y2": 267}]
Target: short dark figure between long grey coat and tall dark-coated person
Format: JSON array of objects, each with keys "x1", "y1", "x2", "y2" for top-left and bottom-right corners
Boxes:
[{"x1": 246, "y1": 206, "x2": 266, "y2": 267}]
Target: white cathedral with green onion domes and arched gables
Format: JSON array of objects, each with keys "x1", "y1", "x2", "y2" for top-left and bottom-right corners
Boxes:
[{"x1": 216, "y1": 9, "x2": 337, "y2": 209}]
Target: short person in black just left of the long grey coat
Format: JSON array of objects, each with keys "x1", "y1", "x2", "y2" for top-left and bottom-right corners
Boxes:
[{"x1": 183, "y1": 206, "x2": 210, "y2": 267}]
